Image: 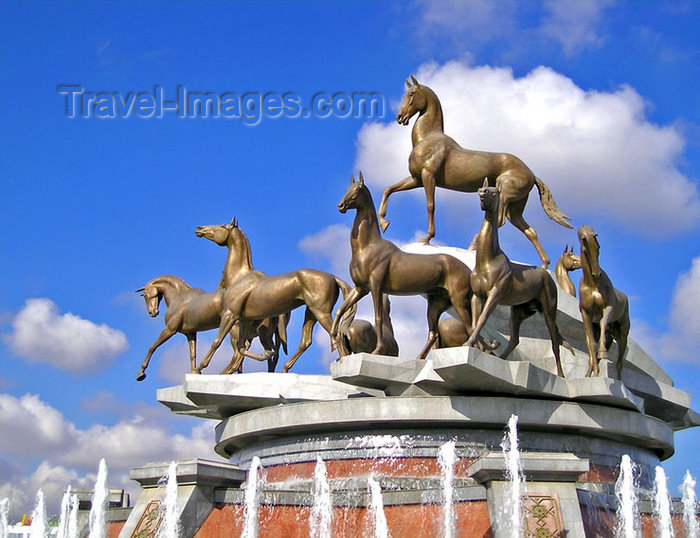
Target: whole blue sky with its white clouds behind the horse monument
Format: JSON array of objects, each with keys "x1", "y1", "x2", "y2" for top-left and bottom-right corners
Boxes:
[{"x1": 0, "y1": 1, "x2": 700, "y2": 512}]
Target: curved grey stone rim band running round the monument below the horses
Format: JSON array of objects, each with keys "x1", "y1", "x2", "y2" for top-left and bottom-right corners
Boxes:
[{"x1": 214, "y1": 396, "x2": 674, "y2": 460}]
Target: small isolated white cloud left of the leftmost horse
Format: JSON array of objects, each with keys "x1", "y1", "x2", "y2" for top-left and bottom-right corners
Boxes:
[{"x1": 3, "y1": 299, "x2": 129, "y2": 372}]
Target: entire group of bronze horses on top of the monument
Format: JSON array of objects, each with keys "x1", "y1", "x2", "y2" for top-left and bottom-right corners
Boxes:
[{"x1": 137, "y1": 76, "x2": 629, "y2": 380}]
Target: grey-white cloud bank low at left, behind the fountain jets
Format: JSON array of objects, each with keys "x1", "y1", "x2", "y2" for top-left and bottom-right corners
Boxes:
[{"x1": 0, "y1": 394, "x2": 220, "y2": 516}]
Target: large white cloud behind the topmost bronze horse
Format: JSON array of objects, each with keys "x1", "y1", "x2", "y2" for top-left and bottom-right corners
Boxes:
[{"x1": 356, "y1": 58, "x2": 700, "y2": 238}]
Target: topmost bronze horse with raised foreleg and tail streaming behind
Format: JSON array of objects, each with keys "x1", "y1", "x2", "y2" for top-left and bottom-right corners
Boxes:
[{"x1": 378, "y1": 75, "x2": 572, "y2": 269}]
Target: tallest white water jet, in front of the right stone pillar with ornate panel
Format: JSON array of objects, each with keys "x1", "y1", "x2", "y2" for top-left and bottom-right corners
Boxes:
[{"x1": 500, "y1": 415, "x2": 525, "y2": 538}]
